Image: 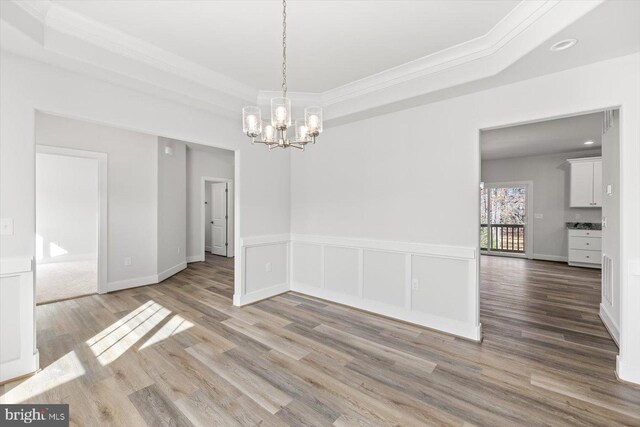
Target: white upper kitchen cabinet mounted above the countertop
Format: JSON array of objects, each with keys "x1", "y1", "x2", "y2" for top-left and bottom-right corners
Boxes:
[{"x1": 567, "y1": 157, "x2": 602, "y2": 208}]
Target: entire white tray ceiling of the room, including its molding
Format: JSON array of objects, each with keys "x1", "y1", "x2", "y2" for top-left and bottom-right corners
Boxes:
[{"x1": 0, "y1": 0, "x2": 640, "y2": 122}]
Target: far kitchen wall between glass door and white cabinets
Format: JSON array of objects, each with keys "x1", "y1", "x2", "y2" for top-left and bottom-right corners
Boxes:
[{"x1": 481, "y1": 150, "x2": 602, "y2": 261}]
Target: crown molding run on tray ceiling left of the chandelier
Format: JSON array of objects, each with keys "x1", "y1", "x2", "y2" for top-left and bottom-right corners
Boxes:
[{"x1": 2, "y1": 0, "x2": 258, "y2": 116}]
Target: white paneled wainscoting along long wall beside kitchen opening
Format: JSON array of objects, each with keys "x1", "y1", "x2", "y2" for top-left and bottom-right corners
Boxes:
[{"x1": 290, "y1": 234, "x2": 482, "y2": 341}]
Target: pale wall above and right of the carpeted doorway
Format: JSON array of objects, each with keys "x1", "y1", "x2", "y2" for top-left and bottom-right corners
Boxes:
[{"x1": 35, "y1": 112, "x2": 158, "y2": 289}]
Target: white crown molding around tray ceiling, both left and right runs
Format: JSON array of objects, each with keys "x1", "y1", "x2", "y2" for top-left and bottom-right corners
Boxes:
[{"x1": 0, "y1": 0, "x2": 604, "y2": 123}]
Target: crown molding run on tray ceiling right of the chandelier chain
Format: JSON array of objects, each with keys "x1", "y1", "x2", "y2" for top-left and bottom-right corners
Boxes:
[{"x1": 322, "y1": 0, "x2": 604, "y2": 123}]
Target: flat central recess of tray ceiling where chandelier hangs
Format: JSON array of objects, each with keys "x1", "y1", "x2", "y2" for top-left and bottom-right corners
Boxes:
[{"x1": 54, "y1": 0, "x2": 519, "y2": 92}]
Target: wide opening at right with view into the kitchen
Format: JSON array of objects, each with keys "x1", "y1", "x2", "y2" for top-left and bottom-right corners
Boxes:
[{"x1": 478, "y1": 108, "x2": 621, "y2": 351}]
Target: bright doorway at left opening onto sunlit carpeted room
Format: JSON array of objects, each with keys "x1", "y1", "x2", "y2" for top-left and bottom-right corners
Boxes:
[{"x1": 35, "y1": 146, "x2": 106, "y2": 304}]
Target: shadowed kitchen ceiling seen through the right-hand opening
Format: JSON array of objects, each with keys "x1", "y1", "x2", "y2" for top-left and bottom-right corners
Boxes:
[{"x1": 480, "y1": 112, "x2": 603, "y2": 160}]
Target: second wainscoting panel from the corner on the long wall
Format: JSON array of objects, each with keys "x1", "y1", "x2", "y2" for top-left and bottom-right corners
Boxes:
[{"x1": 324, "y1": 246, "x2": 361, "y2": 296}]
